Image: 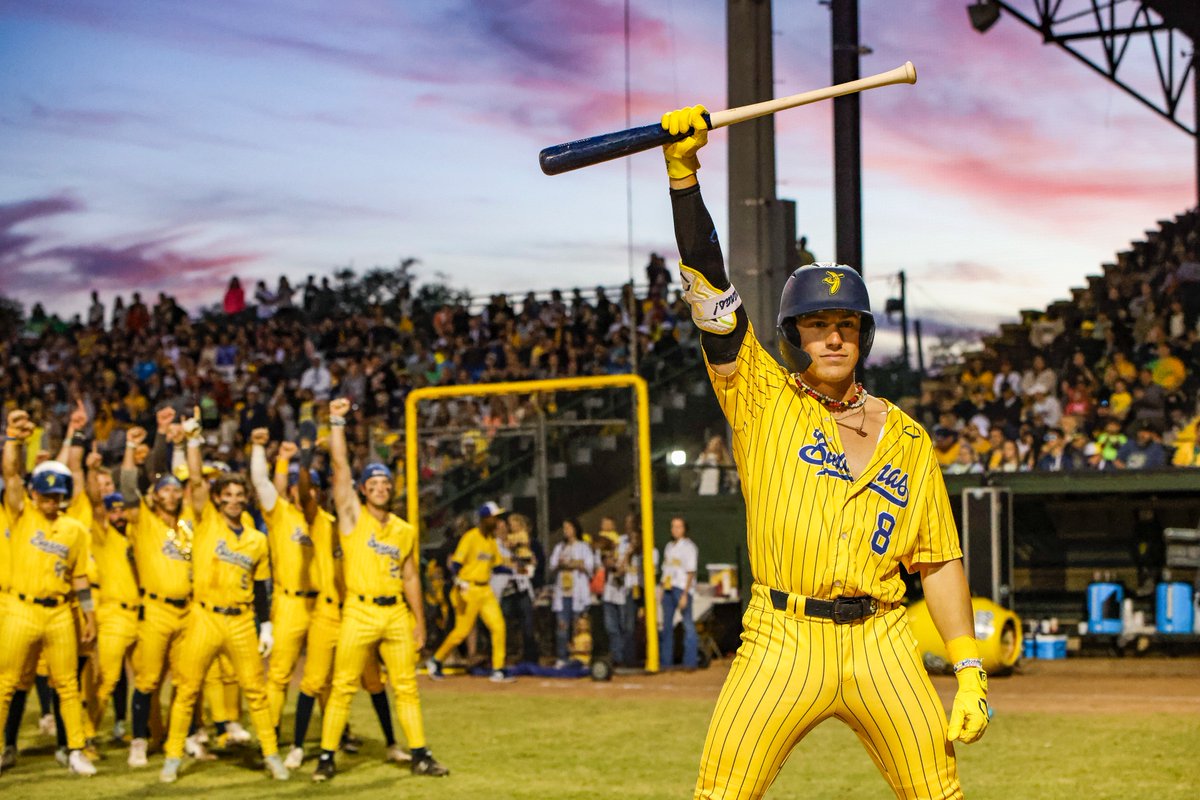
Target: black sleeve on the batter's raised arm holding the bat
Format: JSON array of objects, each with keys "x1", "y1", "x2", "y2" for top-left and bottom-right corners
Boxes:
[{"x1": 671, "y1": 184, "x2": 749, "y2": 363}]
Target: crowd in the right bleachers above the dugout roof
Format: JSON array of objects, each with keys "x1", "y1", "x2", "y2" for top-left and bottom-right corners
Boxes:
[{"x1": 916, "y1": 212, "x2": 1200, "y2": 474}]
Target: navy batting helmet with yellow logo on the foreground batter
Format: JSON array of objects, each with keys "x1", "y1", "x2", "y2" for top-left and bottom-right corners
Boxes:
[{"x1": 778, "y1": 261, "x2": 875, "y2": 372}]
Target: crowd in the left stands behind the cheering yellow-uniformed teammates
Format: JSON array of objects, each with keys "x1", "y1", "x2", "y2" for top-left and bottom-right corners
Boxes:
[{"x1": 0, "y1": 258, "x2": 695, "y2": 513}]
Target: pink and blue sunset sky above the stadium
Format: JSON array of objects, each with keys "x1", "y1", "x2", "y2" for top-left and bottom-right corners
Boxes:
[{"x1": 0, "y1": 0, "x2": 1195, "y2": 352}]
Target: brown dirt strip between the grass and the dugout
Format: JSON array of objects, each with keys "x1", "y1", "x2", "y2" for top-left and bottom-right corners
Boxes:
[{"x1": 436, "y1": 658, "x2": 1200, "y2": 715}]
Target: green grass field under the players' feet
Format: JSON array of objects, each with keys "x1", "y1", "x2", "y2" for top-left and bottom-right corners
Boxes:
[{"x1": 0, "y1": 679, "x2": 1200, "y2": 800}]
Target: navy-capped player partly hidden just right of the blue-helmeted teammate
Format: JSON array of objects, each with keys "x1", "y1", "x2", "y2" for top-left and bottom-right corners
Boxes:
[{"x1": 88, "y1": 491, "x2": 142, "y2": 753}]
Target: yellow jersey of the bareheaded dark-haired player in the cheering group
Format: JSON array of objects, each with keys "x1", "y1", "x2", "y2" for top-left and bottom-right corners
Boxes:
[{"x1": 192, "y1": 504, "x2": 271, "y2": 606}]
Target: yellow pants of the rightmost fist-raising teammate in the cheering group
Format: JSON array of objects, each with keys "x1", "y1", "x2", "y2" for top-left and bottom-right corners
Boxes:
[{"x1": 320, "y1": 597, "x2": 425, "y2": 750}]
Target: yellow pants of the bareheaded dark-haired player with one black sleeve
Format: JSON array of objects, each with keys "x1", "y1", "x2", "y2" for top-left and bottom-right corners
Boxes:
[{"x1": 163, "y1": 606, "x2": 280, "y2": 758}]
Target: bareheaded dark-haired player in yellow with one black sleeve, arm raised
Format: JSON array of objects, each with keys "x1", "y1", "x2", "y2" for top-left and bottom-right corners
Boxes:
[{"x1": 158, "y1": 408, "x2": 288, "y2": 783}]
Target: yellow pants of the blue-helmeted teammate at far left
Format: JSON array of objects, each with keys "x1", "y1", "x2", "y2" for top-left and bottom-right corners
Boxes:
[{"x1": 0, "y1": 600, "x2": 85, "y2": 750}]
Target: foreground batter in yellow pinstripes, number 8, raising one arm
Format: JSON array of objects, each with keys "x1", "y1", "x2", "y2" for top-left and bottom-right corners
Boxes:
[{"x1": 662, "y1": 107, "x2": 988, "y2": 799}]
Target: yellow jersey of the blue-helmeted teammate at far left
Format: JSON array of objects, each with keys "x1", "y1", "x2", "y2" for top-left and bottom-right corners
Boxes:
[{"x1": 11, "y1": 510, "x2": 88, "y2": 597}]
